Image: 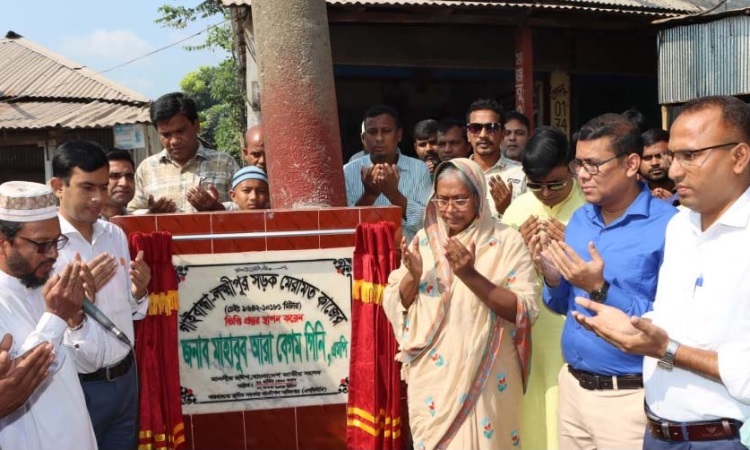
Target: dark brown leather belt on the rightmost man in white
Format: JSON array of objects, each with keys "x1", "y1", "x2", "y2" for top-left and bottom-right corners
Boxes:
[{"x1": 646, "y1": 407, "x2": 742, "y2": 442}]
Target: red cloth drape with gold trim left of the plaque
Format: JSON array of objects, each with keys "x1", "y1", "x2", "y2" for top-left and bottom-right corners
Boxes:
[{"x1": 130, "y1": 231, "x2": 185, "y2": 450}]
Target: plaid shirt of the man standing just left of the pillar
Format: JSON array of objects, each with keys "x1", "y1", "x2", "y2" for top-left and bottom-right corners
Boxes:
[{"x1": 128, "y1": 143, "x2": 239, "y2": 214}]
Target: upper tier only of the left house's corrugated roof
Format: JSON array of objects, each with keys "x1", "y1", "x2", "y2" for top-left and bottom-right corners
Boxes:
[{"x1": 0, "y1": 38, "x2": 149, "y2": 104}]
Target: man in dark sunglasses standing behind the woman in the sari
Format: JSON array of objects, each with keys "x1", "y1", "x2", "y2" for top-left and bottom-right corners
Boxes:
[{"x1": 466, "y1": 99, "x2": 526, "y2": 219}]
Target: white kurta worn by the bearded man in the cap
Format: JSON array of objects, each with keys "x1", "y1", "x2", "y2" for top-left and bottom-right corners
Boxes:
[{"x1": 0, "y1": 271, "x2": 96, "y2": 450}]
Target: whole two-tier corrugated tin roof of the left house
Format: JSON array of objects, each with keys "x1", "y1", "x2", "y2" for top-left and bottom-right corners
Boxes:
[{"x1": 0, "y1": 32, "x2": 150, "y2": 129}]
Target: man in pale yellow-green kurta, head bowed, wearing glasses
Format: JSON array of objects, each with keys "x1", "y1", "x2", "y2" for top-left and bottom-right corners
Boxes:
[{"x1": 502, "y1": 126, "x2": 586, "y2": 449}]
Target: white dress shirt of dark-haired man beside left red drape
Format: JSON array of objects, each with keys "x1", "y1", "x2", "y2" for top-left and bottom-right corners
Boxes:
[{"x1": 55, "y1": 215, "x2": 148, "y2": 373}]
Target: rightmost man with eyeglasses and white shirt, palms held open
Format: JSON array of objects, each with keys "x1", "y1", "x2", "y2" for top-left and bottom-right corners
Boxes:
[{"x1": 576, "y1": 97, "x2": 750, "y2": 450}]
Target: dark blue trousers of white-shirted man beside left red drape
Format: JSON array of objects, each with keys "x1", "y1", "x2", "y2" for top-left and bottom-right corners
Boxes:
[{"x1": 81, "y1": 364, "x2": 138, "y2": 450}]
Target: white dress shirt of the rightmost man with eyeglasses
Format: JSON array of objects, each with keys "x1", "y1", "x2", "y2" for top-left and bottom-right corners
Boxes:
[{"x1": 643, "y1": 189, "x2": 750, "y2": 422}]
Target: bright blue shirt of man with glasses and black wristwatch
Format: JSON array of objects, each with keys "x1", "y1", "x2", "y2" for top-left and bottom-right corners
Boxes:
[{"x1": 543, "y1": 183, "x2": 677, "y2": 375}]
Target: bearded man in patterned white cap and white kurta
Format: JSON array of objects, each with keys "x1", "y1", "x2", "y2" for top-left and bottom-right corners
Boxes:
[{"x1": 0, "y1": 181, "x2": 96, "y2": 450}]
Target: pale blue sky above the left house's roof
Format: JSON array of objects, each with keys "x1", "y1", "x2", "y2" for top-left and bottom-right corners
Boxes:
[{"x1": 0, "y1": 0, "x2": 226, "y2": 99}]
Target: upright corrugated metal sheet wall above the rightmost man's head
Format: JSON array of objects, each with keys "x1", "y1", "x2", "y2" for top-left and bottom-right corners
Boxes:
[{"x1": 658, "y1": 15, "x2": 750, "y2": 104}]
